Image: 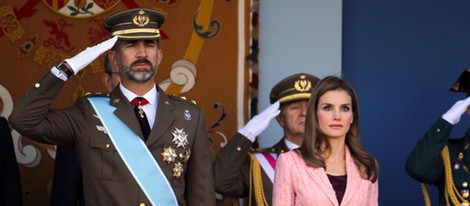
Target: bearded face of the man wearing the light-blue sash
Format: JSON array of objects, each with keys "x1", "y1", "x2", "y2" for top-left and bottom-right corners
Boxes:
[{"x1": 116, "y1": 40, "x2": 162, "y2": 83}]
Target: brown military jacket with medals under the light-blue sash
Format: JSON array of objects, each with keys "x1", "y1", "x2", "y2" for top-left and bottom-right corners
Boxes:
[{"x1": 10, "y1": 73, "x2": 215, "y2": 206}]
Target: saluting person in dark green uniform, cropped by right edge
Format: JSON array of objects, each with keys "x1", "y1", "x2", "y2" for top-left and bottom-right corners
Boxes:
[{"x1": 406, "y1": 69, "x2": 470, "y2": 206}]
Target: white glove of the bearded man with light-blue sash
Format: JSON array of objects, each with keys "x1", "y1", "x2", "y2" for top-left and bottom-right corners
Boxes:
[{"x1": 64, "y1": 36, "x2": 118, "y2": 74}]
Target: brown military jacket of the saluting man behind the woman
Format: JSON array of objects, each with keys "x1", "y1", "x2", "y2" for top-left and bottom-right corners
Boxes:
[{"x1": 215, "y1": 133, "x2": 289, "y2": 205}]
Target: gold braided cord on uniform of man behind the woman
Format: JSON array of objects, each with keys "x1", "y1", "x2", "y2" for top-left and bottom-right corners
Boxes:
[{"x1": 248, "y1": 153, "x2": 268, "y2": 206}]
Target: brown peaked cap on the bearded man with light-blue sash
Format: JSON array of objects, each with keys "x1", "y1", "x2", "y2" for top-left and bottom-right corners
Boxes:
[{"x1": 104, "y1": 8, "x2": 165, "y2": 40}]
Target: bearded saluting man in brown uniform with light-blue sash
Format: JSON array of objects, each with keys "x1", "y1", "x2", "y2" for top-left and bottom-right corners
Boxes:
[{"x1": 10, "y1": 8, "x2": 215, "y2": 206}]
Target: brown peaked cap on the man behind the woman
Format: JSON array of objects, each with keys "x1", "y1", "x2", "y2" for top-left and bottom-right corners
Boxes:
[{"x1": 269, "y1": 73, "x2": 320, "y2": 104}]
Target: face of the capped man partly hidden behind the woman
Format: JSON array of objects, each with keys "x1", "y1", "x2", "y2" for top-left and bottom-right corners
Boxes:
[{"x1": 276, "y1": 100, "x2": 308, "y2": 139}]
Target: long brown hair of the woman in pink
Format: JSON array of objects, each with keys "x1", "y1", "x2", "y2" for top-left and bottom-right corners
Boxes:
[{"x1": 299, "y1": 76, "x2": 379, "y2": 182}]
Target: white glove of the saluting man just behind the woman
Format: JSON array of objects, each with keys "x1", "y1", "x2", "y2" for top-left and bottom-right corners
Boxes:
[{"x1": 238, "y1": 102, "x2": 281, "y2": 142}]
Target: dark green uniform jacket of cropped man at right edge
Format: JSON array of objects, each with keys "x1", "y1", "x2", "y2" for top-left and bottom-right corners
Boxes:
[{"x1": 406, "y1": 118, "x2": 470, "y2": 205}]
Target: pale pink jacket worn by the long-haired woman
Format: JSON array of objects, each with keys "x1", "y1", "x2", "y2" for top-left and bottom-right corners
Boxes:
[{"x1": 273, "y1": 148, "x2": 379, "y2": 206}]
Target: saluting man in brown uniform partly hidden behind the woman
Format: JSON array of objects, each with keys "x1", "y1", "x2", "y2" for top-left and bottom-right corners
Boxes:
[{"x1": 215, "y1": 73, "x2": 319, "y2": 206}]
